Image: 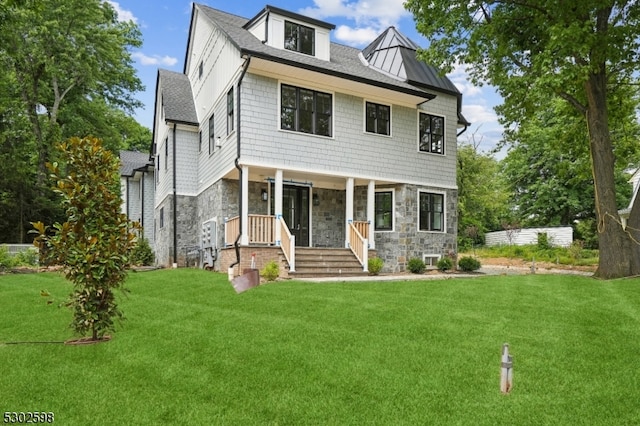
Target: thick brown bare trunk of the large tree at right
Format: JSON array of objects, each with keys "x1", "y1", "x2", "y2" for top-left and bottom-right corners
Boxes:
[{"x1": 585, "y1": 69, "x2": 640, "y2": 279}]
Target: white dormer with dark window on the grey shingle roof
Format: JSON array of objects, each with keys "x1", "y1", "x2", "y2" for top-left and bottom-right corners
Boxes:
[{"x1": 244, "y1": 6, "x2": 335, "y2": 61}]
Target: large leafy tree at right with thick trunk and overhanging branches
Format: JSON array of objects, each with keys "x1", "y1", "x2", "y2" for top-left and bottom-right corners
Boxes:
[{"x1": 405, "y1": 0, "x2": 640, "y2": 278}]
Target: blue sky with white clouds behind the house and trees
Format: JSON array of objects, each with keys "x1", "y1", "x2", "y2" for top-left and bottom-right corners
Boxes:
[{"x1": 109, "y1": 0, "x2": 502, "y2": 151}]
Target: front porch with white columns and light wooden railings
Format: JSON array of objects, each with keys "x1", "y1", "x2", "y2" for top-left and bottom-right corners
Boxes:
[{"x1": 220, "y1": 165, "x2": 388, "y2": 274}]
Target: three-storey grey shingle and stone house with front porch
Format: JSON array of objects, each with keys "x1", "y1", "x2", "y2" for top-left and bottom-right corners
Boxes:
[{"x1": 152, "y1": 4, "x2": 468, "y2": 274}]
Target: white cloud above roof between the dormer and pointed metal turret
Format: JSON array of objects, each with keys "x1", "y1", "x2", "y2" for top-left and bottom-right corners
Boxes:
[{"x1": 298, "y1": 0, "x2": 411, "y2": 45}]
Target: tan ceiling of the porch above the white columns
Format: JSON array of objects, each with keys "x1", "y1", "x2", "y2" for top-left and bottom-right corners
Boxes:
[{"x1": 225, "y1": 166, "x2": 393, "y2": 190}]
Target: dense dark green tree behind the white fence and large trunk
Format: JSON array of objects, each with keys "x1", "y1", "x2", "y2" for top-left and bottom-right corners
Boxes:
[{"x1": 502, "y1": 98, "x2": 638, "y2": 226}]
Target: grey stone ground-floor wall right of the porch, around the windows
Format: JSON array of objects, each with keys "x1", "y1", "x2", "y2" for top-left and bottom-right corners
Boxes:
[{"x1": 354, "y1": 185, "x2": 458, "y2": 272}]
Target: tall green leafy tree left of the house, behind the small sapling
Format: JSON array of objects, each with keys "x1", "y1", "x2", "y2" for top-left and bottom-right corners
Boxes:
[{"x1": 0, "y1": 0, "x2": 146, "y2": 243}]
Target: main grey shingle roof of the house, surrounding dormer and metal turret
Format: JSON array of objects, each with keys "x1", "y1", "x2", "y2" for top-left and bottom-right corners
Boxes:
[{"x1": 196, "y1": 4, "x2": 461, "y2": 105}]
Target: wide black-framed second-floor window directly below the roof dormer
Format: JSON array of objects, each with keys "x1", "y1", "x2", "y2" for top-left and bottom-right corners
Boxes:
[{"x1": 280, "y1": 84, "x2": 333, "y2": 136}]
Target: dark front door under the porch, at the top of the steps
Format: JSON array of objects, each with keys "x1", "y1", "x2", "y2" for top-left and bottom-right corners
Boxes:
[{"x1": 282, "y1": 185, "x2": 309, "y2": 247}]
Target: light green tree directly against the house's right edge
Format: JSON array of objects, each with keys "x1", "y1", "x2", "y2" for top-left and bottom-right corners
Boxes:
[{"x1": 457, "y1": 136, "x2": 508, "y2": 249}]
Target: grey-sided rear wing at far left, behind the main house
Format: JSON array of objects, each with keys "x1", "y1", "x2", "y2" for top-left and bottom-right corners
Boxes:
[{"x1": 120, "y1": 151, "x2": 155, "y2": 248}]
